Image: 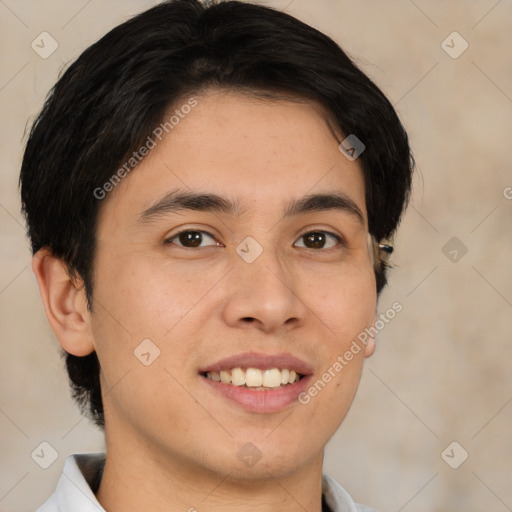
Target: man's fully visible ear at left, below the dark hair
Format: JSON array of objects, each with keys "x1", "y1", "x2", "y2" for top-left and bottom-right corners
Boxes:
[{"x1": 32, "y1": 248, "x2": 94, "y2": 356}]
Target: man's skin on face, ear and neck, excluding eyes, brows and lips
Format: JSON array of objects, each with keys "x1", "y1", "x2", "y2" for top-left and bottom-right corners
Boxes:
[{"x1": 33, "y1": 91, "x2": 377, "y2": 512}]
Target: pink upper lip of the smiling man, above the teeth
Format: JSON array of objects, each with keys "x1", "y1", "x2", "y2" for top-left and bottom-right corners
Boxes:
[{"x1": 199, "y1": 352, "x2": 313, "y2": 374}]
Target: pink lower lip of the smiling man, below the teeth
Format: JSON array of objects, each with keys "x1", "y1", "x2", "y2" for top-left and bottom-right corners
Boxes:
[{"x1": 200, "y1": 370, "x2": 313, "y2": 413}]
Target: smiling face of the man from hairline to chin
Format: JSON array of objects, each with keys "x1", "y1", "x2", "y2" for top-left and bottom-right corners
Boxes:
[{"x1": 90, "y1": 91, "x2": 376, "y2": 484}]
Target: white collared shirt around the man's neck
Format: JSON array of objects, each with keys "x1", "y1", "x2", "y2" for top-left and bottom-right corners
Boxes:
[{"x1": 36, "y1": 453, "x2": 375, "y2": 512}]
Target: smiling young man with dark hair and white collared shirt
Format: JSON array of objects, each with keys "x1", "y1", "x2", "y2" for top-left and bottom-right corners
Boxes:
[{"x1": 20, "y1": 0, "x2": 413, "y2": 512}]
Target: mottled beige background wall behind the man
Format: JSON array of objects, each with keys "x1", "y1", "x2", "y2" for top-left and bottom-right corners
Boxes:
[{"x1": 0, "y1": 0, "x2": 512, "y2": 512}]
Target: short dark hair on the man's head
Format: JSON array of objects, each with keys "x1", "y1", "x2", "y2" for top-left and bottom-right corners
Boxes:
[{"x1": 20, "y1": 0, "x2": 414, "y2": 428}]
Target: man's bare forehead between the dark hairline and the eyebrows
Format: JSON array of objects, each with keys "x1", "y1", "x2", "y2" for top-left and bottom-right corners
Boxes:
[{"x1": 98, "y1": 91, "x2": 366, "y2": 226}]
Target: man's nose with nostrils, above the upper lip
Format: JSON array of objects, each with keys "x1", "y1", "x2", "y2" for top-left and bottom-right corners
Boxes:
[{"x1": 223, "y1": 242, "x2": 308, "y2": 333}]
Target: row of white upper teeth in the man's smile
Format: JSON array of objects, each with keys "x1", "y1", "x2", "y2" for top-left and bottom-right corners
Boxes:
[{"x1": 206, "y1": 368, "x2": 300, "y2": 388}]
